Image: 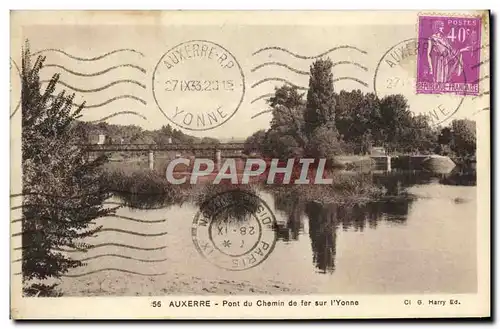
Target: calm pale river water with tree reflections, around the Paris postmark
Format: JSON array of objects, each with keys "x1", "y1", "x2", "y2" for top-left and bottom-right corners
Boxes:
[{"x1": 60, "y1": 172, "x2": 477, "y2": 296}]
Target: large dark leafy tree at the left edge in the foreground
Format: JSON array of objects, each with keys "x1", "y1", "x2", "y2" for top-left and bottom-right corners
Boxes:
[{"x1": 21, "y1": 43, "x2": 114, "y2": 296}]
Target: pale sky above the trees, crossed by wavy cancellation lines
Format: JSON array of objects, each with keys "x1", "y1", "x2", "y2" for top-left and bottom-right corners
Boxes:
[{"x1": 11, "y1": 12, "x2": 489, "y2": 139}]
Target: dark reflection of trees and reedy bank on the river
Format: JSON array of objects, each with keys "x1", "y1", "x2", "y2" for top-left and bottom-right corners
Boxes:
[{"x1": 111, "y1": 167, "x2": 476, "y2": 273}]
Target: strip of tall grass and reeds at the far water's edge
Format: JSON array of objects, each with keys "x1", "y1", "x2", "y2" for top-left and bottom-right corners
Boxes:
[{"x1": 103, "y1": 159, "x2": 385, "y2": 207}]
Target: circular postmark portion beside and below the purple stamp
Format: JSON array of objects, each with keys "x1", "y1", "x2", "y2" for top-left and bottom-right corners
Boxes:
[{"x1": 373, "y1": 38, "x2": 466, "y2": 126}]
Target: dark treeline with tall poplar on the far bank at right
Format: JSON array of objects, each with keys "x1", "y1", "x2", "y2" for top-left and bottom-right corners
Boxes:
[{"x1": 245, "y1": 59, "x2": 476, "y2": 163}]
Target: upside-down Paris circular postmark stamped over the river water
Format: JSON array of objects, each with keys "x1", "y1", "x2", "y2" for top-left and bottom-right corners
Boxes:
[{"x1": 191, "y1": 190, "x2": 276, "y2": 271}]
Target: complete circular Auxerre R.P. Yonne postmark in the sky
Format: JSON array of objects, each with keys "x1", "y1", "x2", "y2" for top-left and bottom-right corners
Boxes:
[{"x1": 153, "y1": 40, "x2": 245, "y2": 130}]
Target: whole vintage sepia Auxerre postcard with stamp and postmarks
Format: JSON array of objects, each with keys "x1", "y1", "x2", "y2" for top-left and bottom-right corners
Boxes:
[{"x1": 10, "y1": 10, "x2": 491, "y2": 319}]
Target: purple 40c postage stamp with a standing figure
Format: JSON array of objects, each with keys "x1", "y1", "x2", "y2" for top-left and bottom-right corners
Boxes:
[{"x1": 417, "y1": 16, "x2": 481, "y2": 95}]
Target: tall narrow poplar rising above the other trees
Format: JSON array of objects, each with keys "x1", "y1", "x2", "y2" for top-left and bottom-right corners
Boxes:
[{"x1": 304, "y1": 58, "x2": 336, "y2": 136}]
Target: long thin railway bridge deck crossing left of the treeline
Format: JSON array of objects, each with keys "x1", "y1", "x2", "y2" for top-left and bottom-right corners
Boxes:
[{"x1": 80, "y1": 143, "x2": 244, "y2": 152}]
